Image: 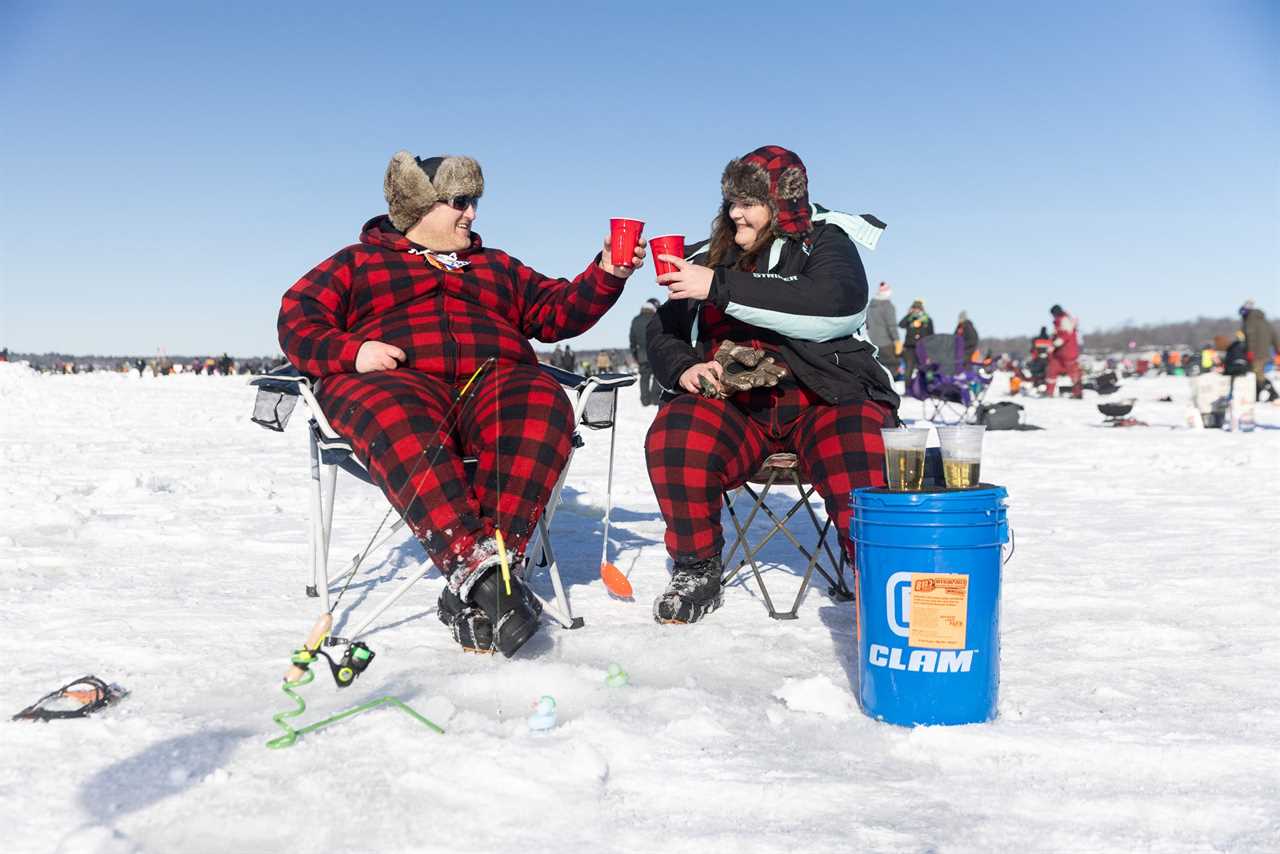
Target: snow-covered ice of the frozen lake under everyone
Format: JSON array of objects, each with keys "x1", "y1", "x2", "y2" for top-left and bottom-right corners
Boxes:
[{"x1": 0, "y1": 364, "x2": 1280, "y2": 854}]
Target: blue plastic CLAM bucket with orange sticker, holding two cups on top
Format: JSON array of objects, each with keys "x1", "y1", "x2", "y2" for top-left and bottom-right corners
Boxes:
[{"x1": 850, "y1": 484, "x2": 1009, "y2": 726}]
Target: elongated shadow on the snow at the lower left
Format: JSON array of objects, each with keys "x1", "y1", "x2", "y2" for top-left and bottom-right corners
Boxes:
[{"x1": 79, "y1": 730, "x2": 257, "y2": 823}]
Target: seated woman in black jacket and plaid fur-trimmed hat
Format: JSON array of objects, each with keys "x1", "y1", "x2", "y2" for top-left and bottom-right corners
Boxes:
[{"x1": 645, "y1": 146, "x2": 899, "y2": 622}]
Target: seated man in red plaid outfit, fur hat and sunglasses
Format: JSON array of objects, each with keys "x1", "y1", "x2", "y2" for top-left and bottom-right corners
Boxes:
[{"x1": 279, "y1": 151, "x2": 645, "y2": 656}]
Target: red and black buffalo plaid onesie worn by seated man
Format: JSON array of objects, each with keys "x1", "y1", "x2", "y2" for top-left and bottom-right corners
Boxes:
[{"x1": 279, "y1": 216, "x2": 623, "y2": 585}]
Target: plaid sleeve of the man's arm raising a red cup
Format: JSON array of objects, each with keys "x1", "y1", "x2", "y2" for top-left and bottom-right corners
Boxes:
[{"x1": 511, "y1": 256, "x2": 626, "y2": 342}]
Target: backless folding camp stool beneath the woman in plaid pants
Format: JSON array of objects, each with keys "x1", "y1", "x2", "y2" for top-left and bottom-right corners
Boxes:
[{"x1": 721, "y1": 453, "x2": 854, "y2": 620}]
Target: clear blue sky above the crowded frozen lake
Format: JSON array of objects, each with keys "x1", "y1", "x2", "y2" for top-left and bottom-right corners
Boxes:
[{"x1": 0, "y1": 0, "x2": 1280, "y2": 355}]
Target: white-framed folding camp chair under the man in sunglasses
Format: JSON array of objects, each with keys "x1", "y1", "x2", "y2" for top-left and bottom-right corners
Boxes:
[{"x1": 250, "y1": 365, "x2": 636, "y2": 644}]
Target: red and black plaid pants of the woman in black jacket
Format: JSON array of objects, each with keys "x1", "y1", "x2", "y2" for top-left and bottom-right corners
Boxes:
[{"x1": 645, "y1": 391, "x2": 896, "y2": 561}]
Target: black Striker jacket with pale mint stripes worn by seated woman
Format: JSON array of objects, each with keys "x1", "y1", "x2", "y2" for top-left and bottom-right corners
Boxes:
[{"x1": 648, "y1": 223, "x2": 899, "y2": 411}]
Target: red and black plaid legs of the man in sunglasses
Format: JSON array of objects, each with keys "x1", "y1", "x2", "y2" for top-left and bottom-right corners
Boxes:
[{"x1": 317, "y1": 362, "x2": 573, "y2": 574}]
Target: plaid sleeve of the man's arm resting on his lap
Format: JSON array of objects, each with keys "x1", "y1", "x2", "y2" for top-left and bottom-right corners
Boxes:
[{"x1": 276, "y1": 250, "x2": 364, "y2": 376}]
